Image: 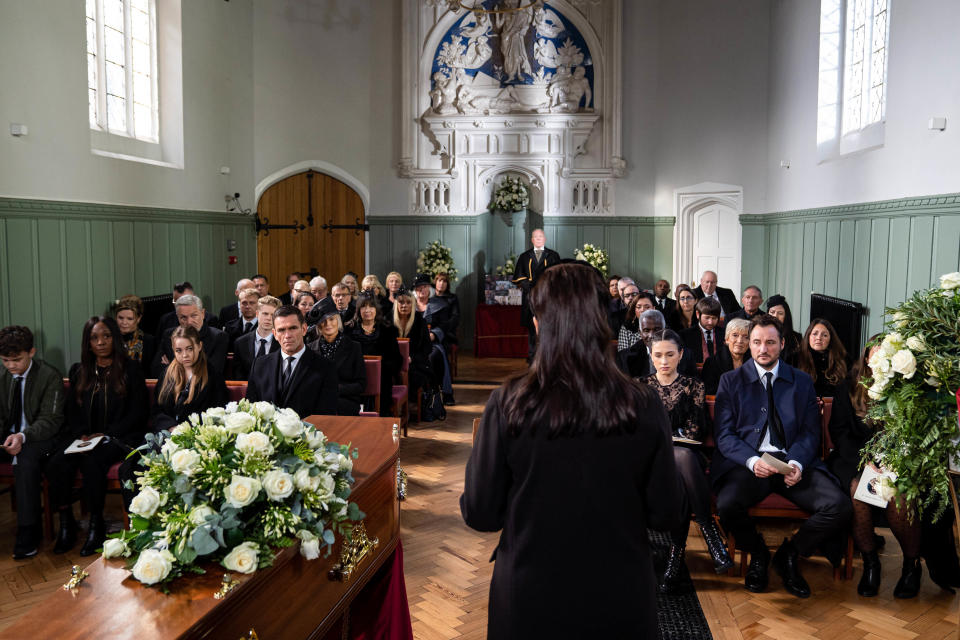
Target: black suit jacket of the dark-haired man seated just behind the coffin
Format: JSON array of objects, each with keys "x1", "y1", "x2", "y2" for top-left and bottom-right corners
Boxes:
[{"x1": 247, "y1": 349, "x2": 338, "y2": 418}]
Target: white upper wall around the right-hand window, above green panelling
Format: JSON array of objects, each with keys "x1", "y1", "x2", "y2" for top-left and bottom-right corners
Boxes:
[{"x1": 764, "y1": 0, "x2": 960, "y2": 213}]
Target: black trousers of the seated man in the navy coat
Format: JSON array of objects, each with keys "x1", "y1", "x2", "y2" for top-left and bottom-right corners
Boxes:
[{"x1": 714, "y1": 466, "x2": 853, "y2": 556}]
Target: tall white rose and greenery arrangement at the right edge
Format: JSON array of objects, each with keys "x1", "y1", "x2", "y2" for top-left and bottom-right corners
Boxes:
[{"x1": 863, "y1": 272, "x2": 960, "y2": 517}]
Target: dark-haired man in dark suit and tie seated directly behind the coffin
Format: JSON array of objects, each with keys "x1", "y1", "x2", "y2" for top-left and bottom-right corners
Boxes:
[{"x1": 247, "y1": 306, "x2": 339, "y2": 418}]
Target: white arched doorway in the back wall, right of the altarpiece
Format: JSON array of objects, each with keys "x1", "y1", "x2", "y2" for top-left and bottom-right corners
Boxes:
[{"x1": 673, "y1": 182, "x2": 743, "y2": 294}]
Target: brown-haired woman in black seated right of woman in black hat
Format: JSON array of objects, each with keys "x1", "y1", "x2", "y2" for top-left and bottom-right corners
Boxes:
[{"x1": 347, "y1": 291, "x2": 403, "y2": 416}]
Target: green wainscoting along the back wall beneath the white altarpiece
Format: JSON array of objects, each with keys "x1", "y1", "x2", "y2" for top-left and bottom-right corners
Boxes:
[{"x1": 367, "y1": 212, "x2": 675, "y2": 349}]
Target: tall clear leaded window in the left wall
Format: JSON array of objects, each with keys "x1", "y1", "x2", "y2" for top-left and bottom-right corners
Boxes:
[{"x1": 86, "y1": 0, "x2": 160, "y2": 142}]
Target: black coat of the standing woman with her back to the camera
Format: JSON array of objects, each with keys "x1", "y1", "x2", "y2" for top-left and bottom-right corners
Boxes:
[{"x1": 460, "y1": 389, "x2": 681, "y2": 640}]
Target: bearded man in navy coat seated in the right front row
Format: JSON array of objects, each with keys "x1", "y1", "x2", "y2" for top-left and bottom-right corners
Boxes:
[{"x1": 710, "y1": 314, "x2": 853, "y2": 598}]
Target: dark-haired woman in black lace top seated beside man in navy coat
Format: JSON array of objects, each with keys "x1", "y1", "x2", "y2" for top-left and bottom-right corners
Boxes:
[{"x1": 642, "y1": 329, "x2": 733, "y2": 593}]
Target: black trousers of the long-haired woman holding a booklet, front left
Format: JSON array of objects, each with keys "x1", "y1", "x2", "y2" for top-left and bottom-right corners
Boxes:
[{"x1": 47, "y1": 440, "x2": 129, "y2": 517}]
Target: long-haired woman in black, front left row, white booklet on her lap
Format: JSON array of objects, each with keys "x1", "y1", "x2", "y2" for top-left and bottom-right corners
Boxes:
[{"x1": 47, "y1": 317, "x2": 148, "y2": 556}]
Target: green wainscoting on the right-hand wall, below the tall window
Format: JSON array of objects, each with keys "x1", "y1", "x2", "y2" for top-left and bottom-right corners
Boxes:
[{"x1": 740, "y1": 194, "x2": 960, "y2": 338}]
